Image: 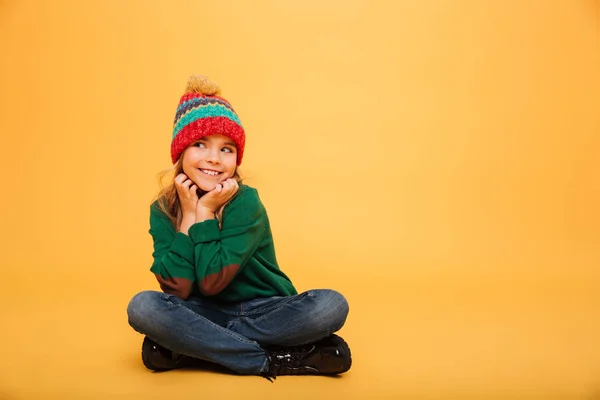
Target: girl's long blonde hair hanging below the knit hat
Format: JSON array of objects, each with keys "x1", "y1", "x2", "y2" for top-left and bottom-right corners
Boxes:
[{"x1": 153, "y1": 154, "x2": 242, "y2": 230}]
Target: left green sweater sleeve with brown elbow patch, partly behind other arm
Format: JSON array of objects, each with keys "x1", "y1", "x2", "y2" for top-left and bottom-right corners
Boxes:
[{"x1": 149, "y1": 204, "x2": 195, "y2": 299}]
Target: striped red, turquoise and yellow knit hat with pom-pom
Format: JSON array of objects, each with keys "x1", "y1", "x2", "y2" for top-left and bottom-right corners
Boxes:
[{"x1": 171, "y1": 75, "x2": 246, "y2": 165}]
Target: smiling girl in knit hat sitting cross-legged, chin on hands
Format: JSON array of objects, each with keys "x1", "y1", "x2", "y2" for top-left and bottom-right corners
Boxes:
[{"x1": 127, "y1": 76, "x2": 352, "y2": 379}]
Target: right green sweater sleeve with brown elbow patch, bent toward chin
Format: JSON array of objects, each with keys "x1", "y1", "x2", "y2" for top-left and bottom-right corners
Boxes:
[{"x1": 188, "y1": 186, "x2": 267, "y2": 296}]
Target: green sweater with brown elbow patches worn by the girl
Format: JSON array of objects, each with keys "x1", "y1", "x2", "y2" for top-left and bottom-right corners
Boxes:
[{"x1": 149, "y1": 184, "x2": 297, "y2": 302}]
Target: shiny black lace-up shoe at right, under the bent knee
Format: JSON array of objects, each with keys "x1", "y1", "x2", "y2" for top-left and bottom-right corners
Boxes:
[{"x1": 263, "y1": 335, "x2": 352, "y2": 380}]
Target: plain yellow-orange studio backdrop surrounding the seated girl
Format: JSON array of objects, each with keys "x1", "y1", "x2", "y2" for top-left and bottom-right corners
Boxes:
[{"x1": 0, "y1": 0, "x2": 600, "y2": 399}]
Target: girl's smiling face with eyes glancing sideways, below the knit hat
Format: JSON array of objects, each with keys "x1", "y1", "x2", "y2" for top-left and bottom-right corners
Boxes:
[{"x1": 181, "y1": 135, "x2": 237, "y2": 192}]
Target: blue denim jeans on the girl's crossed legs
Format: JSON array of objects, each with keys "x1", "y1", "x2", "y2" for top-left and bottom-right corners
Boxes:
[{"x1": 127, "y1": 289, "x2": 348, "y2": 375}]
